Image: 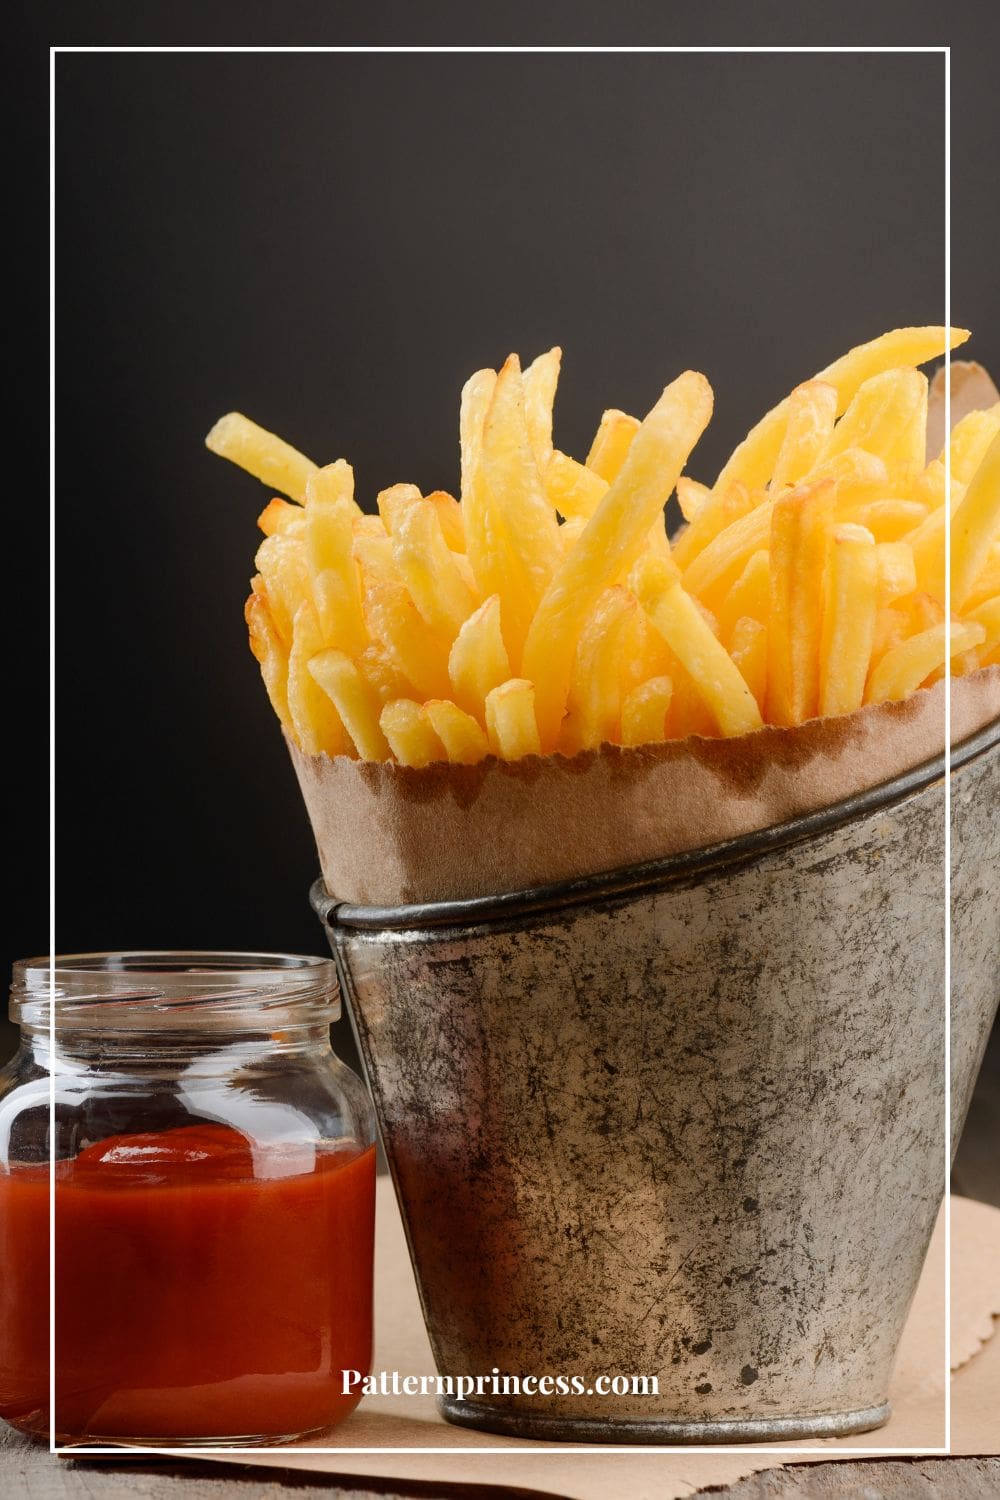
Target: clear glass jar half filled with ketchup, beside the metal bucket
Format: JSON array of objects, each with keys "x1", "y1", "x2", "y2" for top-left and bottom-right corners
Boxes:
[{"x1": 0, "y1": 953, "x2": 375, "y2": 1446}]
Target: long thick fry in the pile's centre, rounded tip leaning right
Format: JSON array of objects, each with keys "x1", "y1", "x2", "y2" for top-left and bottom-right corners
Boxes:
[{"x1": 523, "y1": 371, "x2": 712, "y2": 749}]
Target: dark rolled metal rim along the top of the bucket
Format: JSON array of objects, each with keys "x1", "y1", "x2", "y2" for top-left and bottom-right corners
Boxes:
[{"x1": 309, "y1": 719, "x2": 1000, "y2": 932}]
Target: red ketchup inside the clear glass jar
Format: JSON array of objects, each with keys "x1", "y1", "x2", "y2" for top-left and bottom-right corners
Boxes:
[{"x1": 0, "y1": 1125, "x2": 375, "y2": 1443}]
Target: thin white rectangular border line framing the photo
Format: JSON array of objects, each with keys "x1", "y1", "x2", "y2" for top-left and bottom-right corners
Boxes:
[{"x1": 48, "y1": 45, "x2": 952, "y2": 1458}]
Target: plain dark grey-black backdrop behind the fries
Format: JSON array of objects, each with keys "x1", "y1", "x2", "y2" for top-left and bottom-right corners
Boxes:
[{"x1": 9, "y1": 23, "x2": 1000, "y2": 1188}]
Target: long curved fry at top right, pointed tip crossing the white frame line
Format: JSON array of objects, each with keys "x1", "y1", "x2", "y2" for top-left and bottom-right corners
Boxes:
[{"x1": 714, "y1": 327, "x2": 969, "y2": 489}]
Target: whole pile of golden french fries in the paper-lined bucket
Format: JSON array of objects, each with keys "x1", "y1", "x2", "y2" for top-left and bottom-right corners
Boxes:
[{"x1": 207, "y1": 327, "x2": 1000, "y2": 767}]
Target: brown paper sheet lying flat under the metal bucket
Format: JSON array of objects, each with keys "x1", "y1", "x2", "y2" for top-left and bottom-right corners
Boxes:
[{"x1": 209, "y1": 1179, "x2": 1000, "y2": 1500}]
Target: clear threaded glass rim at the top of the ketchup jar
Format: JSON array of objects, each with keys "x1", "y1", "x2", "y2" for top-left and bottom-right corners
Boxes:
[{"x1": 10, "y1": 948, "x2": 340, "y2": 1031}]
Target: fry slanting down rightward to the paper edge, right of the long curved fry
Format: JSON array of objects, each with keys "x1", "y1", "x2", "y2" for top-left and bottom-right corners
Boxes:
[{"x1": 633, "y1": 558, "x2": 763, "y2": 735}]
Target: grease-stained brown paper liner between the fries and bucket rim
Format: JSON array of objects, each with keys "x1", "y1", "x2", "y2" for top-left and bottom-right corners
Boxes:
[{"x1": 289, "y1": 666, "x2": 1000, "y2": 906}]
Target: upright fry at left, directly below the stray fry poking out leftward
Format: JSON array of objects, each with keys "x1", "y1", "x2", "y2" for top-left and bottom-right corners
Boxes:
[{"x1": 306, "y1": 459, "x2": 367, "y2": 656}]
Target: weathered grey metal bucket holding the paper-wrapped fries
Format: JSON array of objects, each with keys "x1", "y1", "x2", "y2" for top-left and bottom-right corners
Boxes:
[{"x1": 313, "y1": 723, "x2": 1000, "y2": 1443}]
